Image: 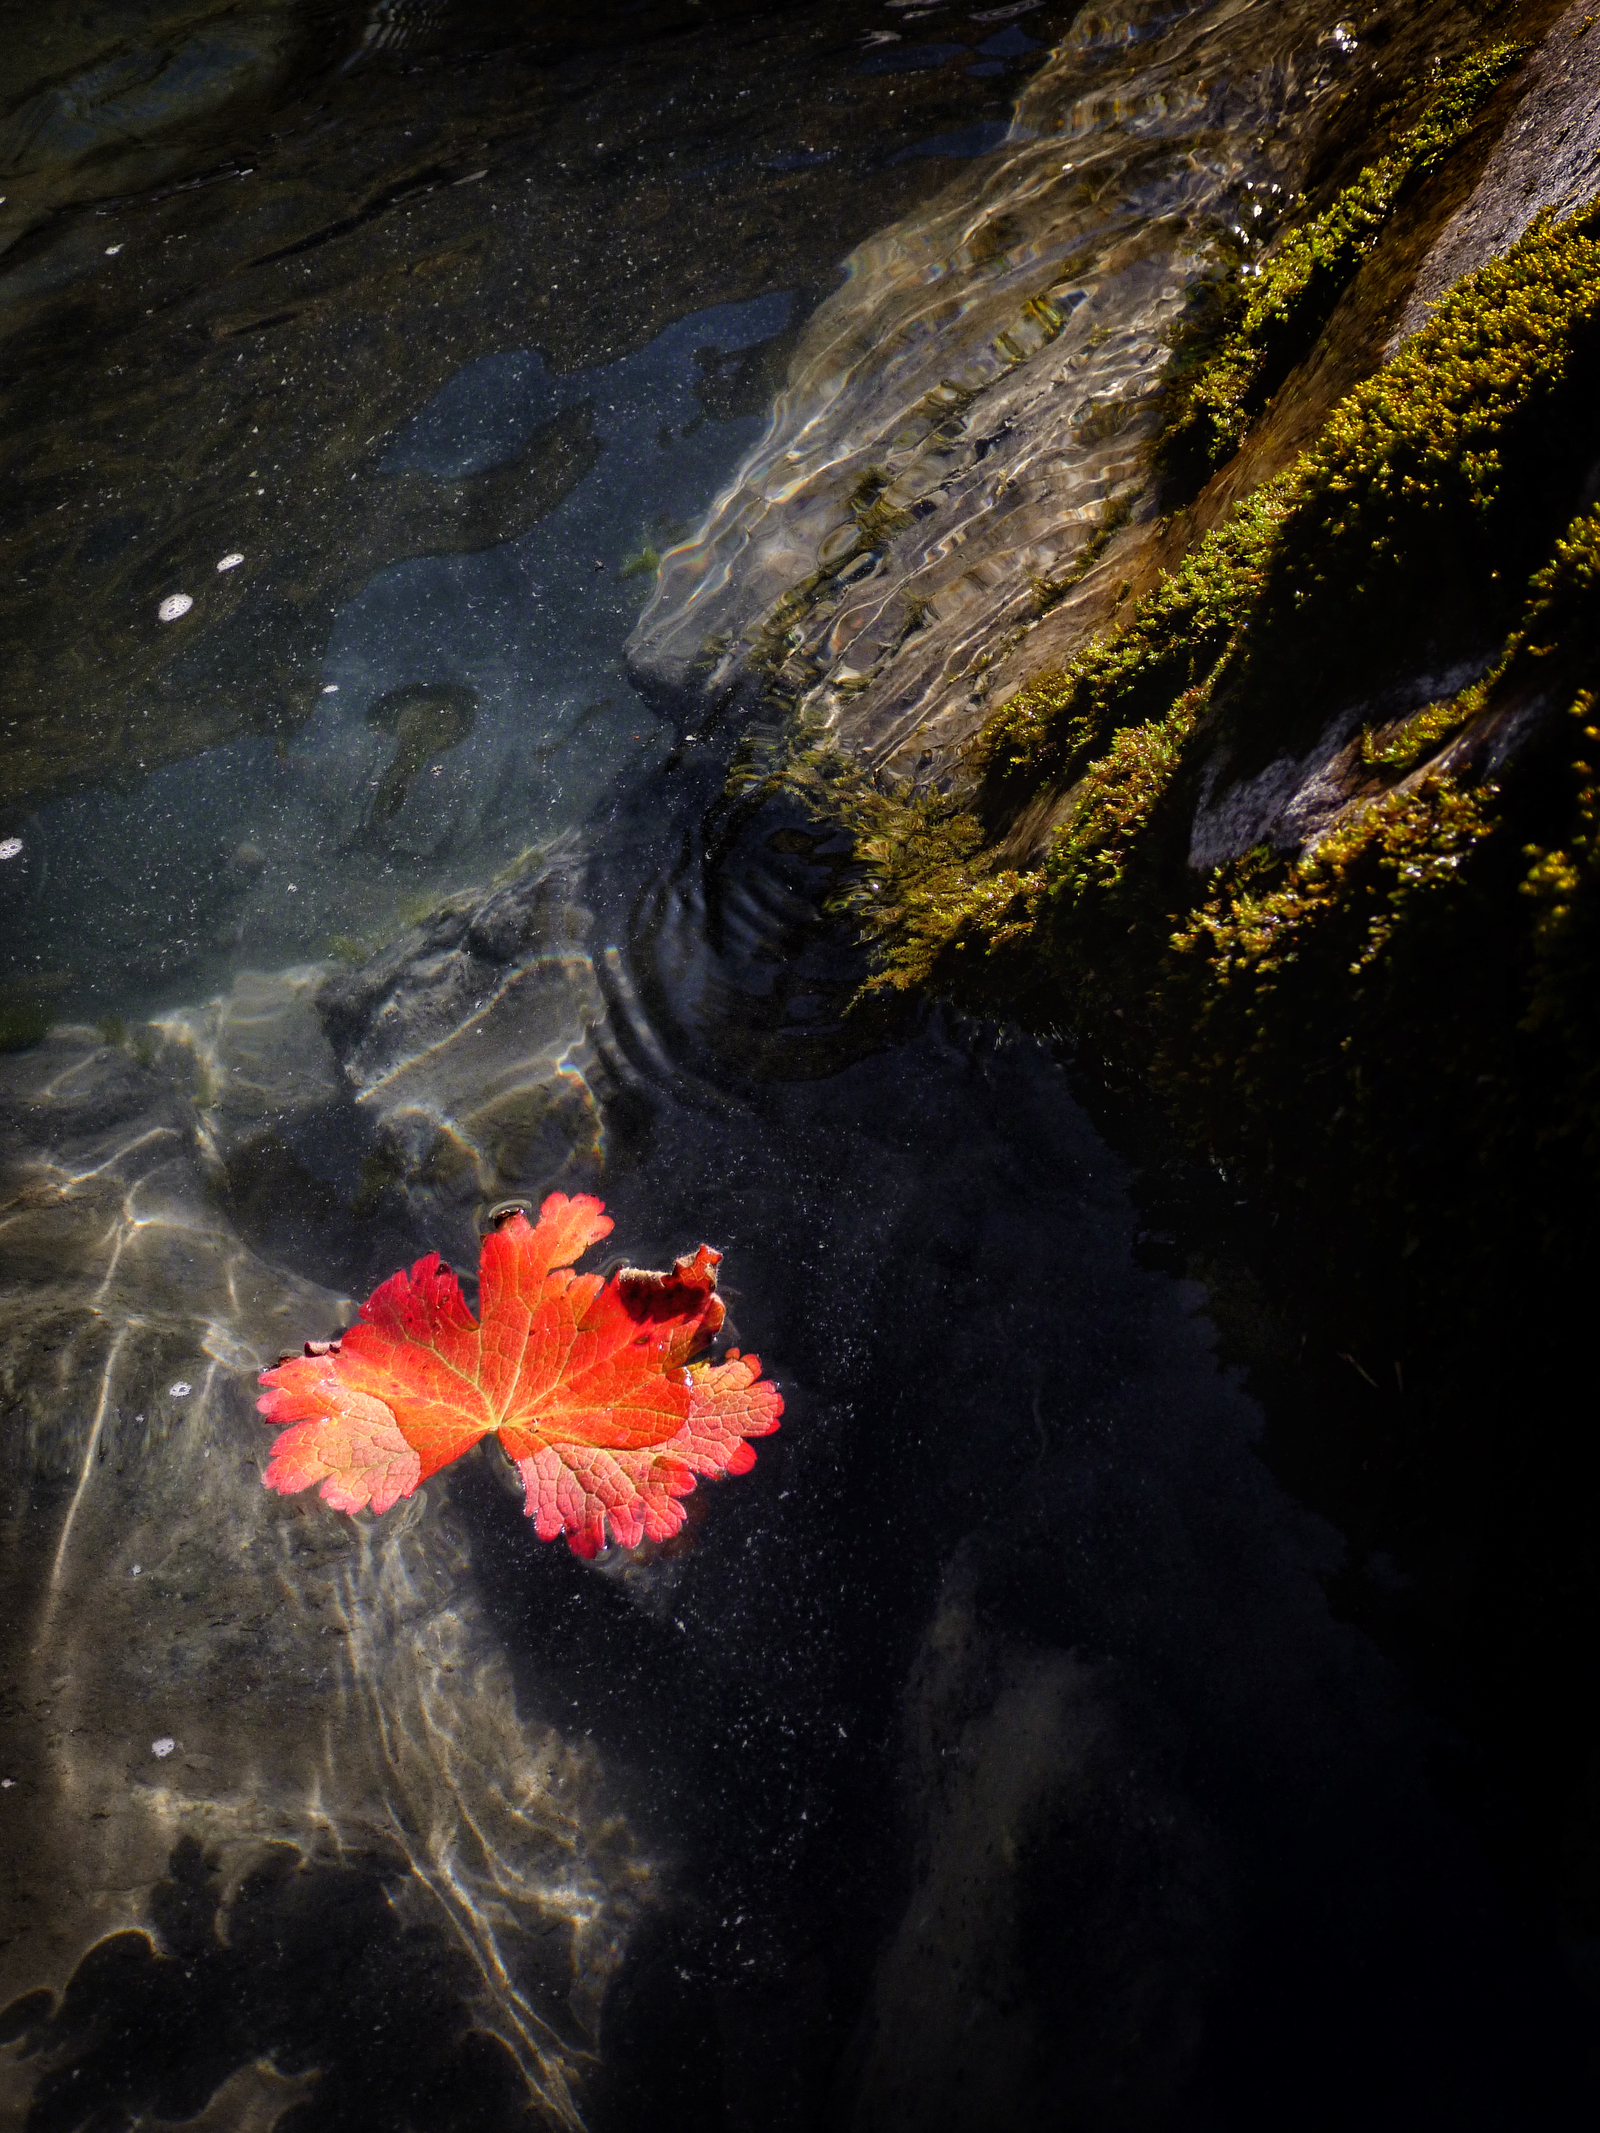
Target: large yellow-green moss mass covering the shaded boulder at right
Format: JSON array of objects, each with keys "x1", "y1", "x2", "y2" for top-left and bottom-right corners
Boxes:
[{"x1": 789, "y1": 203, "x2": 1600, "y2": 1279}]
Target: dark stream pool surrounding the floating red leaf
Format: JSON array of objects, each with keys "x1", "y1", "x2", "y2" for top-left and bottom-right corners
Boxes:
[{"x1": 0, "y1": 0, "x2": 1591, "y2": 2133}]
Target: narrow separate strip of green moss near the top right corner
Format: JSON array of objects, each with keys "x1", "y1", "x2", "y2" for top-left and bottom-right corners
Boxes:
[{"x1": 1161, "y1": 41, "x2": 1527, "y2": 474}]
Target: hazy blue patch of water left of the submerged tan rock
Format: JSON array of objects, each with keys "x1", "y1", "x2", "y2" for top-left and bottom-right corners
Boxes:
[{"x1": 6, "y1": 292, "x2": 794, "y2": 1015}]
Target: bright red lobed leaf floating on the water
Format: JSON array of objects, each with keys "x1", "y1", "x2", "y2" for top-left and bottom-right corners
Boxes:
[{"x1": 258, "y1": 1192, "x2": 783, "y2": 1555}]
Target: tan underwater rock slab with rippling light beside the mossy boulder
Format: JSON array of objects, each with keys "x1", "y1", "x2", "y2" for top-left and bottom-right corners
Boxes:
[{"x1": 629, "y1": 0, "x2": 1382, "y2": 776}]
